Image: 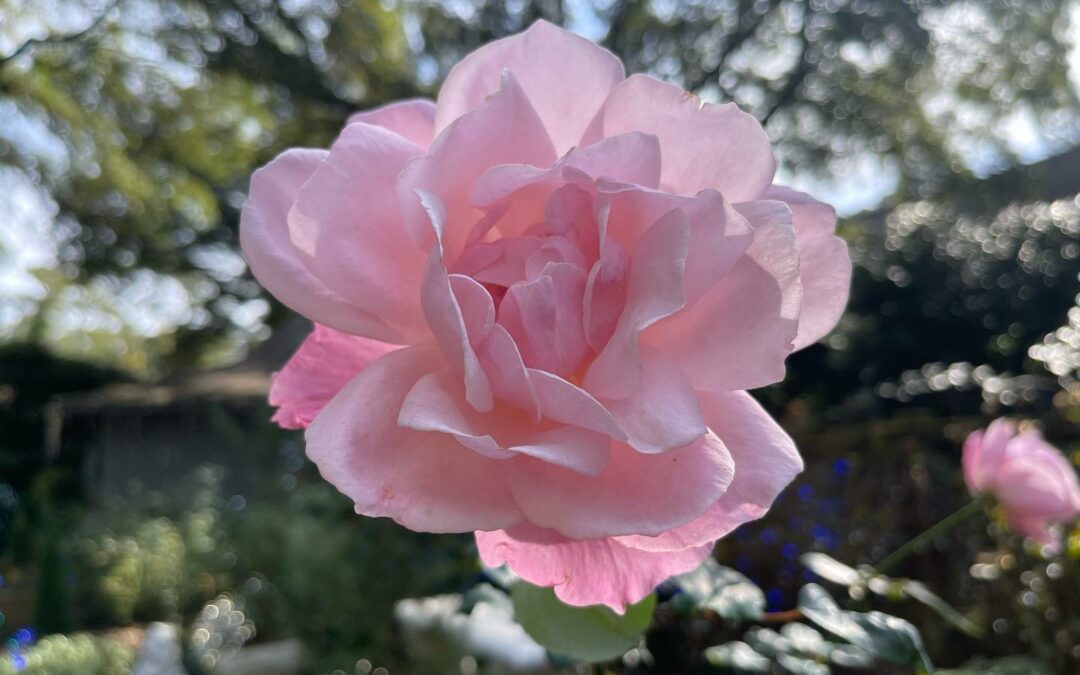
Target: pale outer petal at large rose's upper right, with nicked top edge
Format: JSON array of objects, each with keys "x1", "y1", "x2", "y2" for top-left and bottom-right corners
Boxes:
[{"x1": 585, "y1": 75, "x2": 777, "y2": 203}]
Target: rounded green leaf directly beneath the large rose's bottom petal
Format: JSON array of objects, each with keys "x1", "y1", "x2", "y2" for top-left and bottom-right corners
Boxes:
[{"x1": 510, "y1": 581, "x2": 657, "y2": 663}]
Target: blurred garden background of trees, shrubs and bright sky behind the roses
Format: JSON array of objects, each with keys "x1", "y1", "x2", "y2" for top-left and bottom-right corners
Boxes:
[{"x1": 0, "y1": 0, "x2": 1080, "y2": 675}]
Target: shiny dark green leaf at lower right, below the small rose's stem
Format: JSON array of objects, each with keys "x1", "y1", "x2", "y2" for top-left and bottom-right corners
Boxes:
[{"x1": 799, "y1": 583, "x2": 933, "y2": 673}]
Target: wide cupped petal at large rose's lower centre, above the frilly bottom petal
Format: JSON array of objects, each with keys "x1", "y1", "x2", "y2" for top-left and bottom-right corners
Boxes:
[{"x1": 503, "y1": 433, "x2": 734, "y2": 539}]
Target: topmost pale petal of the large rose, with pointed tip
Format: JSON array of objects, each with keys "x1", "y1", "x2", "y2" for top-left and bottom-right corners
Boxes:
[{"x1": 435, "y1": 21, "x2": 625, "y2": 153}]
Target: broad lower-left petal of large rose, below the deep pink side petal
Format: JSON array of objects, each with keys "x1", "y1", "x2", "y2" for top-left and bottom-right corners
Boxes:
[{"x1": 306, "y1": 347, "x2": 522, "y2": 532}]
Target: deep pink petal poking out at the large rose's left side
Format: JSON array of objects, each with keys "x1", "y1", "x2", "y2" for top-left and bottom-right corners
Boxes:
[{"x1": 270, "y1": 324, "x2": 397, "y2": 429}]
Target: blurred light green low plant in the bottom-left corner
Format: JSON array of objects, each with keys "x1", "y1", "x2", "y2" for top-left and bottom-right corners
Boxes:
[{"x1": 0, "y1": 634, "x2": 135, "y2": 675}]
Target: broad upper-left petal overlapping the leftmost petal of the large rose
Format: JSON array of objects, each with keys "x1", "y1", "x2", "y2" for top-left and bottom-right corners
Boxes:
[{"x1": 288, "y1": 123, "x2": 431, "y2": 341}]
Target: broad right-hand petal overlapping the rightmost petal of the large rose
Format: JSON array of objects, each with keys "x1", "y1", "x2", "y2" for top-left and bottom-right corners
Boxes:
[{"x1": 642, "y1": 202, "x2": 802, "y2": 391}]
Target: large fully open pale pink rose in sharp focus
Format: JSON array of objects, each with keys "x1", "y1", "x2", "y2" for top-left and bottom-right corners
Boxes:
[{"x1": 241, "y1": 22, "x2": 851, "y2": 610}]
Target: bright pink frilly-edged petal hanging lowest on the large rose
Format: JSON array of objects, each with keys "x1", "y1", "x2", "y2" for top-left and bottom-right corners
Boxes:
[{"x1": 476, "y1": 524, "x2": 712, "y2": 613}]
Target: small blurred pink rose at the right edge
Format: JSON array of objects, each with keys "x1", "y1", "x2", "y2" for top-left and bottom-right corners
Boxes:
[{"x1": 963, "y1": 418, "x2": 1080, "y2": 551}]
